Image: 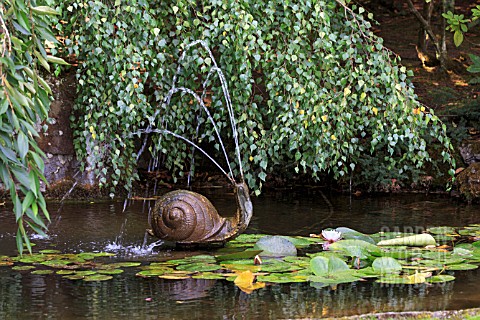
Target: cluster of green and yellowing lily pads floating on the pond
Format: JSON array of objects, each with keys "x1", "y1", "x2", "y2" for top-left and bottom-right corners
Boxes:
[{"x1": 0, "y1": 225, "x2": 480, "y2": 292}]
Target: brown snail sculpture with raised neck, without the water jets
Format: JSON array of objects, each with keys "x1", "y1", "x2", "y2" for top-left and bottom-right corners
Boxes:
[{"x1": 149, "y1": 182, "x2": 253, "y2": 247}]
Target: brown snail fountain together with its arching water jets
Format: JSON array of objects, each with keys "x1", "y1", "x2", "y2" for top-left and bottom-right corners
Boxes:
[{"x1": 137, "y1": 40, "x2": 253, "y2": 247}]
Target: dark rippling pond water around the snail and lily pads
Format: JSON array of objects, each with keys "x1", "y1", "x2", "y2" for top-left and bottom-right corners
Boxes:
[{"x1": 0, "y1": 190, "x2": 480, "y2": 319}]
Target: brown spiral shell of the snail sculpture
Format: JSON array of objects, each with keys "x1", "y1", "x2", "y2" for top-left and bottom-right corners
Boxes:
[{"x1": 149, "y1": 190, "x2": 233, "y2": 244}]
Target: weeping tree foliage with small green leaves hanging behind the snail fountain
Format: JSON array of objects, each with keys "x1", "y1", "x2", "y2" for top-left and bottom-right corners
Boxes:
[{"x1": 47, "y1": 0, "x2": 455, "y2": 195}]
